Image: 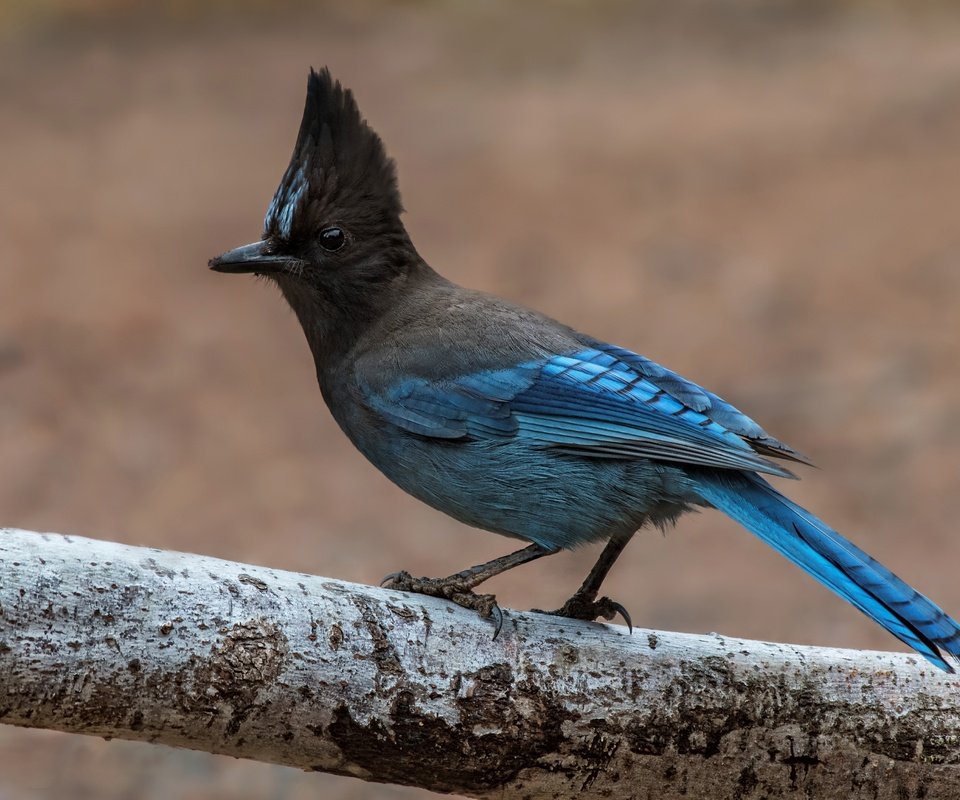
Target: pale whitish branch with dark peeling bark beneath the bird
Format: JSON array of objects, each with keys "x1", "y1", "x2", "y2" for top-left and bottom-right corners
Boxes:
[{"x1": 0, "y1": 529, "x2": 960, "y2": 800}]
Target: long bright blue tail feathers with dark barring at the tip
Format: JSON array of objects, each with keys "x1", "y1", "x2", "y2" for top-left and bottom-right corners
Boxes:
[{"x1": 697, "y1": 471, "x2": 960, "y2": 672}]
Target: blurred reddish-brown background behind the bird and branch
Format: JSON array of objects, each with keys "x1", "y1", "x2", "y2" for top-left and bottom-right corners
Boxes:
[{"x1": 0, "y1": 0, "x2": 960, "y2": 800}]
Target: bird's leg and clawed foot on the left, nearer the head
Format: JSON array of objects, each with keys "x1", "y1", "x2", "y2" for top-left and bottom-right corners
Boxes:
[{"x1": 380, "y1": 544, "x2": 556, "y2": 639}]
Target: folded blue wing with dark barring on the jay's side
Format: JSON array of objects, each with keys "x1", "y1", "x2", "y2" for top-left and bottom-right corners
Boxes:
[{"x1": 367, "y1": 345, "x2": 804, "y2": 477}]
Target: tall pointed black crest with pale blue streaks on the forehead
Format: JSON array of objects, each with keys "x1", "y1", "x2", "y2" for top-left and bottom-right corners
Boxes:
[{"x1": 263, "y1": 67, "x2": 403, "y2": 241}]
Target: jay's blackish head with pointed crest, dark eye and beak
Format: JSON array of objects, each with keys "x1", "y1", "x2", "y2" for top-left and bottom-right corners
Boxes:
[{"x1": 210, "y1": 68, "x2": 419, "y2": 328}]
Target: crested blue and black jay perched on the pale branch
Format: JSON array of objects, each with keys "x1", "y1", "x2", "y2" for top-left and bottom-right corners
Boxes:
[{"x1": 209, "y1": 68, "x2": 960, "y2": 673}]
